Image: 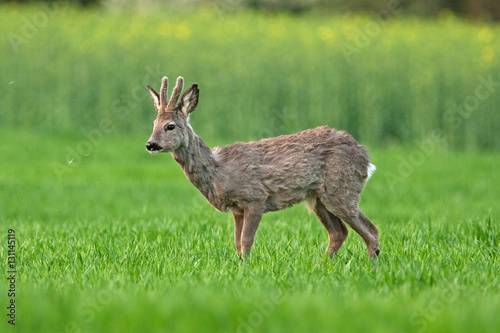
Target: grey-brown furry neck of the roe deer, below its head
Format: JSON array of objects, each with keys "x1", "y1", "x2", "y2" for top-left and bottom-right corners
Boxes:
[{"x1": 172, "y1": 130, "x2": 215, "y2": 201}]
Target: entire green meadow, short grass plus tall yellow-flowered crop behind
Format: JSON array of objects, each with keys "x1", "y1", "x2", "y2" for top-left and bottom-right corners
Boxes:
[{"x1": 0, "y1": 5, "x2": 500, "y2": 332}]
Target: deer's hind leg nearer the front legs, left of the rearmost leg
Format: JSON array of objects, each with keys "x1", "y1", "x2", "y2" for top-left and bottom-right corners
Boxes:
[{"x1": 313, "y1": 199, "x2": 348, "y2": 258}]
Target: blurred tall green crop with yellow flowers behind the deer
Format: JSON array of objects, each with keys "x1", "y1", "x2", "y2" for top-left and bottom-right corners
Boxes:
[{"x1": 0, "y1": 6, "x2": 500, "y2": 149}]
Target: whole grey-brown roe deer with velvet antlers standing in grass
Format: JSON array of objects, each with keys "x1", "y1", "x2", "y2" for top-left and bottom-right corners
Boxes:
[{"x1": 146, "y1": 77, "x2": 379, "y2": 258}]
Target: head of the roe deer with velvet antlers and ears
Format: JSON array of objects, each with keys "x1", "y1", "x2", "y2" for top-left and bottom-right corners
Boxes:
[{"x1": 146, "y1": 76, "x2": 199, "y2": 154}]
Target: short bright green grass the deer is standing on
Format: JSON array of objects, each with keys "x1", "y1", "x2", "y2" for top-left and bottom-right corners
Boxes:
[{"x1": 0, "y1": 130, "x2": 500, "y2": 332}]
